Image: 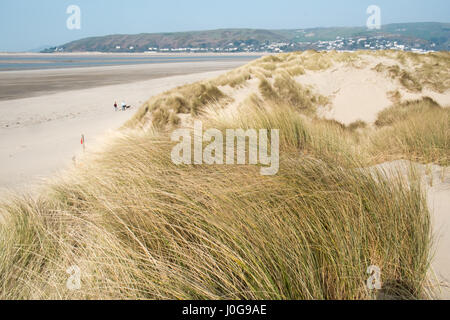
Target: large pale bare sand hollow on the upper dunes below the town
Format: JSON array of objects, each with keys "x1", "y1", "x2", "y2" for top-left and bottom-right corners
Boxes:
[{"x1": 296, "y1": 55, "x2": 450, "y2": 125}]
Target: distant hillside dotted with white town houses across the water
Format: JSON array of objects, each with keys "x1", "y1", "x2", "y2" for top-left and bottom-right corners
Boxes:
[{"x1": 45, "y1": 22, "x2": 450, "y2": 52}]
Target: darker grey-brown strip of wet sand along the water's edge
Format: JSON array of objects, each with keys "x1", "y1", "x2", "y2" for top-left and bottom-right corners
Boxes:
[{"x1": 0, "y1": 57, "x2": 256, "y2": 100}]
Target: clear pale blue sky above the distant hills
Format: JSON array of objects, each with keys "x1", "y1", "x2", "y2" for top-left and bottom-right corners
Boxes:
[{"x1": 0, "y1": 0, "x2": 450, "y2": 51}]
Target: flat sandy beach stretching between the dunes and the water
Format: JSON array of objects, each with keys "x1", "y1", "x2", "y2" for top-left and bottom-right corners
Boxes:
[{"x1": 0, "y1": 61, "x2": 251, "y2": 193}]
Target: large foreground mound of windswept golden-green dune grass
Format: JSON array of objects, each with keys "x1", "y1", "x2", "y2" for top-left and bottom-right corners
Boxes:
[{"x1": 0, "y1": 100, "x2": 430, "y2": 299}]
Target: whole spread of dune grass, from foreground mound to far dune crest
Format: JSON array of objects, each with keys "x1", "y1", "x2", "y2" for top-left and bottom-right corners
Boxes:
[{"x1": 0, "y1": 51, "x2": 442, "y2": 299}]
